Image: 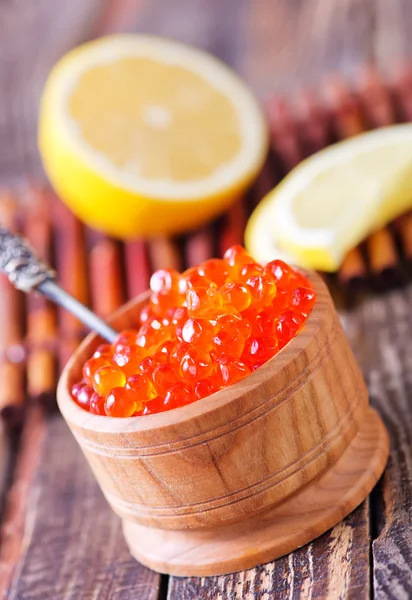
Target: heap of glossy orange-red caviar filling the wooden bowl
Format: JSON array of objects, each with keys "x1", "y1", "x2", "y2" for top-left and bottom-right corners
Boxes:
[{"x1": 71, "y1": 246, "x2": 315, "y2": 417}]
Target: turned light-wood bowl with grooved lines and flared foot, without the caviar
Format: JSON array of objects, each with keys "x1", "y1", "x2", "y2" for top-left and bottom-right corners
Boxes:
[{"x1": 58, "y1": 275, "x2": 389, "y2": 576}]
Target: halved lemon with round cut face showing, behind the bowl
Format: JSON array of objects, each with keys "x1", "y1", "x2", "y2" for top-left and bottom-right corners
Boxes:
[{"x1": 39, "y1": 35, "x2": 268, "y2": 238}]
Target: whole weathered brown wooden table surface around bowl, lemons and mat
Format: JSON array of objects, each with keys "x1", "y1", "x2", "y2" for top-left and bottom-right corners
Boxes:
[{"x1": 0, "y1": 0, "x2": 412, "y2": 600}]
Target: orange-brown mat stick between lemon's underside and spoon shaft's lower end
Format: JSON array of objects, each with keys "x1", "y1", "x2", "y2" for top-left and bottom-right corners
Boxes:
[{"x1": 89, "y1": 236, "x2": 125, "y2": 318}]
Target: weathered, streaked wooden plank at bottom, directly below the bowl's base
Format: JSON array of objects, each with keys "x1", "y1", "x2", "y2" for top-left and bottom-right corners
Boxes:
[{"x1": 168, "y1": 503, "x2": 369, "y2": 600}]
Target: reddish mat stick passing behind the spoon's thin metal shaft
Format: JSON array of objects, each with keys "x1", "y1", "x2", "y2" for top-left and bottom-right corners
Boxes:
[{"x1": 52, "y1": 198, "x2": 88, "y2": 369}]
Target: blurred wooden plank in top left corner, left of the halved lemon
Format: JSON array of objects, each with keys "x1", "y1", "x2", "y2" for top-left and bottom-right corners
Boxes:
[{"x1": 0, "y1": 0, "x2": 101, "y2": 181}]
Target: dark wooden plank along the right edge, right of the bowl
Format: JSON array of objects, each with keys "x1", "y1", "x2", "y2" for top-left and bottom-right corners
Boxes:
[{"x1": 346, "y1": 286, "x2": 412, "y2": 600}]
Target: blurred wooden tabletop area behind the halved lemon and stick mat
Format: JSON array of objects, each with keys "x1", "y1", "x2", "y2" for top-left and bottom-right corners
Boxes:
[{"x1": 0, "y1": 0, "x2": 412, "y2": 180}]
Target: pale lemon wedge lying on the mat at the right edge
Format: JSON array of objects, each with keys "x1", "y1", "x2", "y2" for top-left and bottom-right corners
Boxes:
[{"x1": 245, "y1": 124, "x2": 412, "y2": 271}]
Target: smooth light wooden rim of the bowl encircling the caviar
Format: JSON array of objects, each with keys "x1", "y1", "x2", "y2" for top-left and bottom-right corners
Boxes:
[{"x1": 57, "y1": 272, "x2": 328, "y2": 435}]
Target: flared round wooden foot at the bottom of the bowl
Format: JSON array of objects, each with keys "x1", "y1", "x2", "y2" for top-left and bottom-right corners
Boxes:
[{"x1": 123, "y1": 408, "x2": 389, "y2": 576}]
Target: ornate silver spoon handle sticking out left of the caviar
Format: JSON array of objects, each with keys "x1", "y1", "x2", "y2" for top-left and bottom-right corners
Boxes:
[{"x1": 0, "y1": 227, "x2": 117, "y2": 343}]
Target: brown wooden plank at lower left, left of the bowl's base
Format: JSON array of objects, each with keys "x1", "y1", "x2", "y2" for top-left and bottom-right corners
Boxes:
[{"x1": 6, "y1": 416, "x2": 160, "y2": 600}]
